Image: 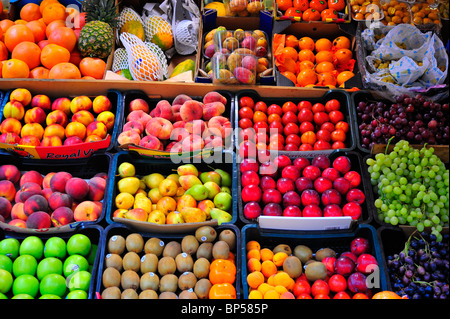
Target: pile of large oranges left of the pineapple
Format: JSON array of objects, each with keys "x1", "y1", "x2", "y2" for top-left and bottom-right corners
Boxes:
[{"x1": 0, "y1": 0, "x2": 106, "y2": 79}]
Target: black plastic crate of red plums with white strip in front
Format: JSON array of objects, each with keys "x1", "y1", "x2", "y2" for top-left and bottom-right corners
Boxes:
[{"x1": 237, "y1": 151, "x2": 375, "y2": 228}]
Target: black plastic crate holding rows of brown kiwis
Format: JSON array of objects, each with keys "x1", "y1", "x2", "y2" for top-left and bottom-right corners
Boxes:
[{"x1": 95, "y1": 223, "x2": 242, "y2": 299}]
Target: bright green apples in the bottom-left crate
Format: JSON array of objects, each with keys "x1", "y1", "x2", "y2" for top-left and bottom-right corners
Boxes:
[{"x1": 0, "y1": 233, "x2": 98, "y2": 299}]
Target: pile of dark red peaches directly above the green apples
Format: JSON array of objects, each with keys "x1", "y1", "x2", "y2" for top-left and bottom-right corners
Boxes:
[{"x1": 0, "y1": 164, "x2": 107, "y2": 229}]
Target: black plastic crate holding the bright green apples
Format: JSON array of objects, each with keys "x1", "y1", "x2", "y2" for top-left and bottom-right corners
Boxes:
[{"x1": 0, "y1": 224, "x2": 104, "y2": 299}]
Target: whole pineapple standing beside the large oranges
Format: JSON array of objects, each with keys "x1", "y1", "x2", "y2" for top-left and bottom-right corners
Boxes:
[{"x1": 78, "y1": 0, "x2": 118, "y2": 59}]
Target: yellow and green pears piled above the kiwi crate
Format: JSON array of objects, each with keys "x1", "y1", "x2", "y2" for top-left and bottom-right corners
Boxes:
[{"x1": 113, "y1": 162, "x2": 233, "y2": 225}]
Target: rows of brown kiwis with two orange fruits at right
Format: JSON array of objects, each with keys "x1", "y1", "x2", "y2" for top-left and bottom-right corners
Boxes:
[{"x1": 101, "y1": 226, "x2": 239, "y2": 299}]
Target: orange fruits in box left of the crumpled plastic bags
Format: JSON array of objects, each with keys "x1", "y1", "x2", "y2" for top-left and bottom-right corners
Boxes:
[{"x1": 274, "y1": 34, "x2": 355, "y2": 88}]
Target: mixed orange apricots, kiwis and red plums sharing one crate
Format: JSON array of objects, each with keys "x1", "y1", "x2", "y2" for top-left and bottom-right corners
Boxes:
[{"x1": 245, "y1": 237, "x2": 384, "y2": 299}]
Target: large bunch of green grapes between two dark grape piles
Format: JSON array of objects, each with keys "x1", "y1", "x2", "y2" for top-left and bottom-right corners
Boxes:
[{"x1": 366, "y1": 140, "x2": 449, "y2": 241}]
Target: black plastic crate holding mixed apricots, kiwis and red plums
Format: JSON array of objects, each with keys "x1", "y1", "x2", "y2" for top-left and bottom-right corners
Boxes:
[{"x1": 241, "y1": 224, "x2": 387, "y2": 299}]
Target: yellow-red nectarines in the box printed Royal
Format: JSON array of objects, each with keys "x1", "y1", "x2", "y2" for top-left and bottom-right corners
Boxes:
[{"x1": 0, "y1": 88, "x2": 115, "y2": 147}]
